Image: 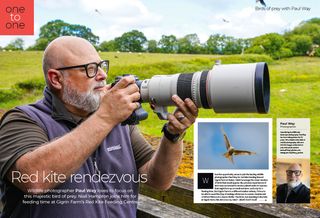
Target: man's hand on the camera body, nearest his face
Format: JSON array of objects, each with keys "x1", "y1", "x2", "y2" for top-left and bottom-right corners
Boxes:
[{"x1": 97, "y1": 76, "x2": 140, "y2": 125}]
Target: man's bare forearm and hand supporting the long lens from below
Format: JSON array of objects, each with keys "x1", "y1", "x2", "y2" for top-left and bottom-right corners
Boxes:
[{"x1": 139, "y1": 95, "x2": 198, "y2": 190}]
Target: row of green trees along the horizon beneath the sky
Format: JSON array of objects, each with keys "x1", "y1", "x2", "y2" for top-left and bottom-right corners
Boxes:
[{"x1": 2, "y1": 18, "x2": 320, "y2": 59}]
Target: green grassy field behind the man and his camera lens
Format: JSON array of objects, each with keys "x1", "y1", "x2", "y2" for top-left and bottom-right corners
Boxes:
[{"x1": 0, "y1": 52, "x2": 320, "y2": 164}]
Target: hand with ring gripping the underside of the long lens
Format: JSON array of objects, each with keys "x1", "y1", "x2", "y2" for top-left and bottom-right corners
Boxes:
[{"x1": 168, "y1": 95, "x2": 198, "y2": 134}]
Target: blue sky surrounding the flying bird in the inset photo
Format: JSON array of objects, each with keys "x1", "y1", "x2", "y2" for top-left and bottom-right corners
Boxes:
[{"x1": 198, "y1": 122, "x2": 271, "y2": 169}]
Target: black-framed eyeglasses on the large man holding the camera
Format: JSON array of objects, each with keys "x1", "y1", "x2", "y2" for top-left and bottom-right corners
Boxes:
[{"x1": 56, "y1": 60, "x2": 109, "y2": 78}]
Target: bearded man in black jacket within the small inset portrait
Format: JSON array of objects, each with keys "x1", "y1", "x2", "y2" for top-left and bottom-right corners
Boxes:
[{"x1": 277, "y1": 163, "x2": 310, "y2": 203}]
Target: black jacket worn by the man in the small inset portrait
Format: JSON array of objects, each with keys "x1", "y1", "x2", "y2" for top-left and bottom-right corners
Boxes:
[{"x1": 277, "y1": 183, "x2": 310, "y2": 203}]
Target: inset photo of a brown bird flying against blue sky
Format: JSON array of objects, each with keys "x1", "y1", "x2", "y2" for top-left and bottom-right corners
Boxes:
[{"x1": 195, "y1": 118, "x2": 272, "y2": 169}]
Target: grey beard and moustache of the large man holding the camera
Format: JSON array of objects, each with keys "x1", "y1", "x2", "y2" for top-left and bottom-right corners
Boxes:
[{"x1": 62, "y1": 81, "x2": 105, "y2": 113}]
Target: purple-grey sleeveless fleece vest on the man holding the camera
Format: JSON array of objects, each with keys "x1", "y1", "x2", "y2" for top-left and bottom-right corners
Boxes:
[{"x1": 1, "y1": 89, "x2": 139, "y2": 218}]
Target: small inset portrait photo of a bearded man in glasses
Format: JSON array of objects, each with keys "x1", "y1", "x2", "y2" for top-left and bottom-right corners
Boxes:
[{"x1": 276, "y1": 158, "x2": 310, "y2": 203}]
